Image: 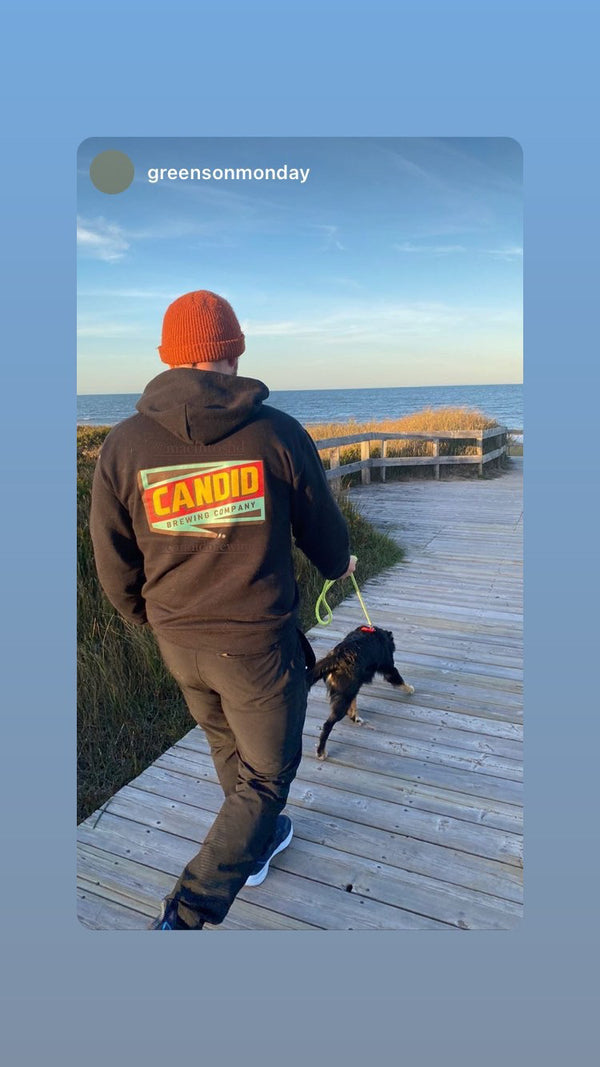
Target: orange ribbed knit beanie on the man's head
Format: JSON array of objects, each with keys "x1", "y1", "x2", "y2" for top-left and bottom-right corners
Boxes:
[{"x1": 158, "y1": 289, "x2": 246, "y2": 367}]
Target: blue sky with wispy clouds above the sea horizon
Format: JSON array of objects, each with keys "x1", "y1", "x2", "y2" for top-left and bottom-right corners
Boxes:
[{"x1": 78, "y1": 138, "x2": 522, "y2": 393}]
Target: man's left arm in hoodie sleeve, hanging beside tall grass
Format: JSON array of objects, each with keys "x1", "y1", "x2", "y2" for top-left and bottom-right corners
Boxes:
[{"x1": 90, "y1": 456, "x2": 147, "y2": 625}]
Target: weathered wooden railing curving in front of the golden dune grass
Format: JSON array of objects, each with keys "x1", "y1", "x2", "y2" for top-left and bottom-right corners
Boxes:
[{"x1": 315, "y1": 426, "x2": 508, "y2": 485}]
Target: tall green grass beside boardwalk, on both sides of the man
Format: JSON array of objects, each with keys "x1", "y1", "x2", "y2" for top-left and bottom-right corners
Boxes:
[{"x1": 77, "y1": 427, "x2": 402, "y2": 819}]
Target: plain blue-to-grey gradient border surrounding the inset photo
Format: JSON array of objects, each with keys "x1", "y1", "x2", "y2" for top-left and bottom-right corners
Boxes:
[{"x1": 0, "y1": 0, "x2": 599, "y2": 1067}]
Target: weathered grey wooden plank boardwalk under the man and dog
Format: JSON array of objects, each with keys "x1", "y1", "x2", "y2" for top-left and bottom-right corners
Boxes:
[{"x1": 78, "y1": 460, "x2": 522, "y2": 930}]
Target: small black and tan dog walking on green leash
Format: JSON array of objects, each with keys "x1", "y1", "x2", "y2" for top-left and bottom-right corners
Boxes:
[{"x1": 309, "y1": 626, "x2": 414, "y2": 760}]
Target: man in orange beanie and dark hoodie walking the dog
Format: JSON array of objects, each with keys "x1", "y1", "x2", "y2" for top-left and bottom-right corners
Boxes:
[{"x1": 90, "y1": 290, "x2": 356, "y2": 929}]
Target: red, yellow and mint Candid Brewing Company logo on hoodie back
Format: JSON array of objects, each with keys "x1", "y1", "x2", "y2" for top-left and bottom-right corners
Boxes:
[{"x1": 139, "y1": 460, "x2": 265, "y2": 537}]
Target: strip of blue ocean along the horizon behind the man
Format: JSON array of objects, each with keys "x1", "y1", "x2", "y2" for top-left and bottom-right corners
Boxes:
[{"x1": 77, "y1": 385, "x2": 523, "y2": 430}]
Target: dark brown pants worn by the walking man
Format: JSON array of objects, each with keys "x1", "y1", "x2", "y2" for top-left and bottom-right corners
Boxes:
[{"x1": 157, "y1": 627, "x2": 307, "y2": 926}]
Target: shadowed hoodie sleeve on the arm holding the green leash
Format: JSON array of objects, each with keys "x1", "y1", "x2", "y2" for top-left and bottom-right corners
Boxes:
[{"x1": 291, "y1": 430, "x2": 353, "y2": 578}]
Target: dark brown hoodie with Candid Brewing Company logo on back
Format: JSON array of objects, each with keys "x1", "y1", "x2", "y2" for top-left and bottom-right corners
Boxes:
[{"x1": 90, "y1": 368, "x2": 349, "y2": 651}]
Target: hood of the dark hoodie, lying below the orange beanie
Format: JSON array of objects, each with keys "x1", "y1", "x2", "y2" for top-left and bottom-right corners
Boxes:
[{"x1": 136, "y1": 367, "x2": 269, "y2": 445}]
